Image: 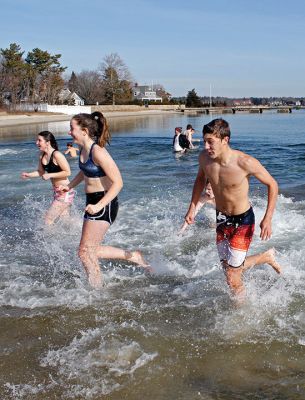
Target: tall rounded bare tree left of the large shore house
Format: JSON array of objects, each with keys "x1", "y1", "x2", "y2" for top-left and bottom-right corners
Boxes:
[{"x1": 99, "y1": 53, "x2": 132, "y2": 105}]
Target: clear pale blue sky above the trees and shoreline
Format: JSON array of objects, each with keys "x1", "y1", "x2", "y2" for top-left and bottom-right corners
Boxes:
[{"x1": 0, "y1": 0, "x2": 305, "y2": 97}]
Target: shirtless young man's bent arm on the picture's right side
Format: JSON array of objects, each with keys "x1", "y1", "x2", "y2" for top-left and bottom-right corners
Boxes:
[{"x1": 250, "y1": 158, "x2": 278, "y2": 240}]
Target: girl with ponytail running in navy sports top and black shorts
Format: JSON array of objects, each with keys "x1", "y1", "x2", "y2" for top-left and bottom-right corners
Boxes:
[{"x1": 61, "y1": 112, "x2": 150, "y2": 288}]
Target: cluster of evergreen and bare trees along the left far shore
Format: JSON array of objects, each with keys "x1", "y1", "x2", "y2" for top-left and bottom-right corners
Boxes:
[{"x1": 0, "y1": 43, "x2": 132, "y2": 108}]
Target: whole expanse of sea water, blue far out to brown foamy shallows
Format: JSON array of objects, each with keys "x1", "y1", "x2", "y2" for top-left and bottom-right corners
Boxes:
[{"x1": 0, "y1": 111, "x2": 305, "y2": 400}]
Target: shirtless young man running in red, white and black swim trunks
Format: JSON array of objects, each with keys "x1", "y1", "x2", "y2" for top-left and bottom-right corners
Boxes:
[{"x1": 185, "y1": 119, "x2": 281, "y2": 299}]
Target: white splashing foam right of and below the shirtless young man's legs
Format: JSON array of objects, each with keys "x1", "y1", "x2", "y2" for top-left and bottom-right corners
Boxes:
[{"x1": 210, "y1": 196, "x2": 305, "y2": 342}]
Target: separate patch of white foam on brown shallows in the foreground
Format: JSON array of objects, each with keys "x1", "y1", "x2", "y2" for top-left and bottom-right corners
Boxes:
[{"x1": 40, "y1": 324, "x2": 157, "y2": 399}]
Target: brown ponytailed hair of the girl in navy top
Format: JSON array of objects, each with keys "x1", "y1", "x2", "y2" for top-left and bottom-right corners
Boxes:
[{"x1": 72, "y1": 111, "x2": 111, "y2": 147}]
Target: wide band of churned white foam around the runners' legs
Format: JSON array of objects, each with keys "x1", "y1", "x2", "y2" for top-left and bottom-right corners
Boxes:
[{"x1": 1, "y1": 189, "x2": 305, "y2": 346}]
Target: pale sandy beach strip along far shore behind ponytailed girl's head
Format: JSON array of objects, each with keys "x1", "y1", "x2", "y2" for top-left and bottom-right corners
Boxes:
[{"x1": 0, "y1": 110, "x2": 177, "y2": 128}]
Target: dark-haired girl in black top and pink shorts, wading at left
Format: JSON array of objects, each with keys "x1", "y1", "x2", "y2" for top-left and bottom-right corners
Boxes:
[{"x1": 21, "y1": 131, "x2": 75, "y2": 225}]
